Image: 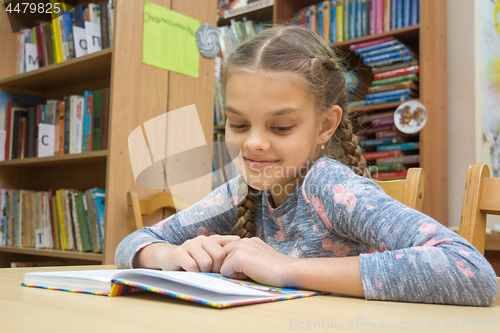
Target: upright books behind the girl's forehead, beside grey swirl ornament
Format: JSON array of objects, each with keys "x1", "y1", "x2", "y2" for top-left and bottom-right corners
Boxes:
[{"x1": 214, "y1": 18, "x2": 267, "y2": 126}]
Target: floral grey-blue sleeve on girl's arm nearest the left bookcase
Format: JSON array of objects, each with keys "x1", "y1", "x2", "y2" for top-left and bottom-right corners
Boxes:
[{"x1": 115, "y1": 178, "x2": 238, "y2": 268}]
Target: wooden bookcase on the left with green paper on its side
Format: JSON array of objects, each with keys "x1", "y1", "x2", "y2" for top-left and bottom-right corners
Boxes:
[{"x1": 0, "y1": 0, "x2": 217, "y2": 267}]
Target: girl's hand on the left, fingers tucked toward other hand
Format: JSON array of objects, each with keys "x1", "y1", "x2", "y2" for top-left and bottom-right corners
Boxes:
[{"x1": 157, "y1": 235, "x2": 240, "y2": 273}]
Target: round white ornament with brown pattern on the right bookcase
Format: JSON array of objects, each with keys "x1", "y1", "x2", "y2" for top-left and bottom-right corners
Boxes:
[{"x1": 394, "y1": 101, "x2": 427, "y2": 134}]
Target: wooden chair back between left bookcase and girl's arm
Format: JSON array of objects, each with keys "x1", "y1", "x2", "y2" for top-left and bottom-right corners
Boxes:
[{"x1": 127, "y1": 191, "x2": 192, "y2": 231}]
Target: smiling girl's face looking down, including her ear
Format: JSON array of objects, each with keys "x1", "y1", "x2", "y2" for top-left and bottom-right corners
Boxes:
[{"x1": 225, "y1": 72, "x2": 342, "y2": 206}]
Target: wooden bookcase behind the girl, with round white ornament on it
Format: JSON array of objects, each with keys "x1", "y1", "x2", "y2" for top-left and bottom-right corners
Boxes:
[{"x1": 219, "y1": 0, "x2": 448, "y2": 225}]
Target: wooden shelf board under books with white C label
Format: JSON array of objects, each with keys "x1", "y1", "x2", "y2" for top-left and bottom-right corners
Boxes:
[{"x1": 0, "y1": 150, "x2": 108, "y2": 168}]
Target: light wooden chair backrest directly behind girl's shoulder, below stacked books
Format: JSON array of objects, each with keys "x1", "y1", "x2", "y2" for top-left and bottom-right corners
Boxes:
[{"x1": 375, "y1": 168, "x2": 425, "y2": 212}]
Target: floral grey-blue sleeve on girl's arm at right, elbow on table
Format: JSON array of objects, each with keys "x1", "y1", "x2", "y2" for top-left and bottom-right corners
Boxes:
[{"x1": 303, "y1": 159, "x2": 498, "y2": 306}]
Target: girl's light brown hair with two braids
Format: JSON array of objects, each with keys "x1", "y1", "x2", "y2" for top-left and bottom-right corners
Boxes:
[{"x1": 221, "y1": 26, "x2": 370, "y2": 238}]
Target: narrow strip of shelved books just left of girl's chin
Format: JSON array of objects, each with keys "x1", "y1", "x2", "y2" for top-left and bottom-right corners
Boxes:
[{"x1": 212, "y1": 131, "x2": 240, "y2": 189}]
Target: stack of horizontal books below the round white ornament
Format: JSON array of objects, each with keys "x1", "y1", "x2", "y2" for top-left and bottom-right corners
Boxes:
[{"x1": 358, "y1": 111, "x2": 420, "y2": 179}]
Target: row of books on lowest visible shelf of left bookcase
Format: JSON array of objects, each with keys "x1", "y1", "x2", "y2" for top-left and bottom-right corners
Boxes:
[{"x1": 0, "y1": 188, "x2": 105, "y2": 253}]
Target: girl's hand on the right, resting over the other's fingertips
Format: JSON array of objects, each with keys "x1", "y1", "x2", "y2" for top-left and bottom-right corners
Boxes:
[{"x1": 220, "y1": 237, "x2": 294, "y2": 287}]
